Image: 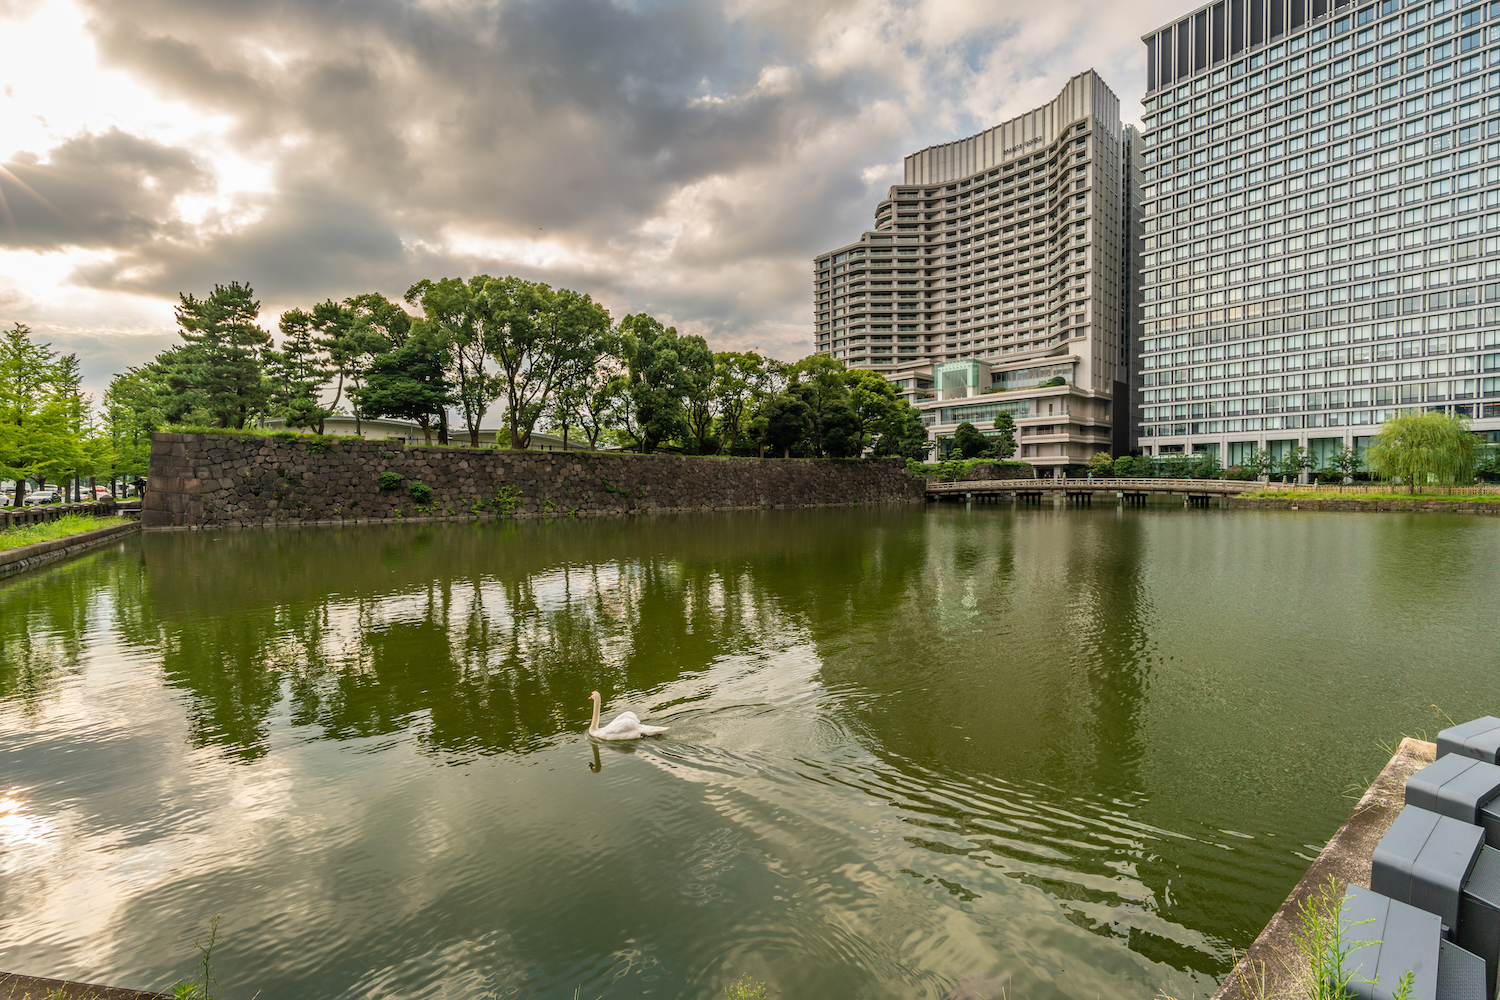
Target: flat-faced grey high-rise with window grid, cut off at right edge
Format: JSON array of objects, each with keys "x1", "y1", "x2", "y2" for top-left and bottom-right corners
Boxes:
[{"x1": 1137, "y1": 0, "x2": 1500, "y2": 468}]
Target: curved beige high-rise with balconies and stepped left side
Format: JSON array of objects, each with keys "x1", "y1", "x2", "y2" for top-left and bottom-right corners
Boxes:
[{"x1": 813, "y1": 70, "x2": 1139, "y2": 469}]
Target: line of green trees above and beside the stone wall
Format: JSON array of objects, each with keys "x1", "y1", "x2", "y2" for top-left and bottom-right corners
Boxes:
[{"x1": 0, "y1": 274, "x2": 929, "y2": 503}]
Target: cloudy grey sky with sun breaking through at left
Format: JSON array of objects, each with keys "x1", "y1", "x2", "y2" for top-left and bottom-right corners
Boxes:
[{"x1": 0, "y1": 0, "x2": 1187, "y2": 391}]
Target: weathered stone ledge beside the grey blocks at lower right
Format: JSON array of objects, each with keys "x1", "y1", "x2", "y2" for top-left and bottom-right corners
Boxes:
[{"x1": 1214, "y1": 738, "x2": 1437, "y2": 1000}]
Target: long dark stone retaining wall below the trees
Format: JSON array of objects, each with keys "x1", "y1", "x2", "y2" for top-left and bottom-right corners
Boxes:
[{"x1": 141, "y1": 433, "x2": 923, "y2": 528}]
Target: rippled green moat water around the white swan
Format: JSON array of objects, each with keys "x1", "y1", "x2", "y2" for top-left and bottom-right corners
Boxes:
[{"x1": 0, "y1": 505, "x2": 1500, "y2": 1000}]
